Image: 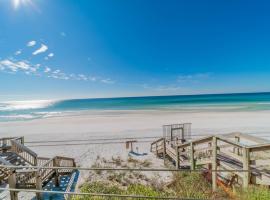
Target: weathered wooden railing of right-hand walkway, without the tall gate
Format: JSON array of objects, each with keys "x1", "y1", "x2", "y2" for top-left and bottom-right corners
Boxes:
[{"x1": 151, "y1": 133, "x2": 270, "y2": 190}]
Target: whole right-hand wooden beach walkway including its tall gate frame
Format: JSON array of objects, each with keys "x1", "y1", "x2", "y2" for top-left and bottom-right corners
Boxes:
[{"x1": 151, "y1": 123, "x2": 270, "y2": 191}]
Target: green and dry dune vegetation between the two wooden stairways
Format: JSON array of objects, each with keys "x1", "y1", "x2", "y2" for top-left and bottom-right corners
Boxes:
[{"x1": 74, "y1": 157, "x2": 227, "y2": 200}]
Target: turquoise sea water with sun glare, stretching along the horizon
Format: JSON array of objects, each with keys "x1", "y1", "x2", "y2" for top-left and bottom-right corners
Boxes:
[{"x1": 0, "y1": 93, "x2": 270, "y2": 121}]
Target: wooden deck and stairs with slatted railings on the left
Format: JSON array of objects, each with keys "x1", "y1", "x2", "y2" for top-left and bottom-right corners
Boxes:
[{"x1": 0, "y1": 137, "x2": 76, "y2": 200}]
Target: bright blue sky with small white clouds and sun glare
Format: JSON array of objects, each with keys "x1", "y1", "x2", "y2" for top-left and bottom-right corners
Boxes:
[{"x1": 0, "y1": 0, "x2": 270, "y2": 101}]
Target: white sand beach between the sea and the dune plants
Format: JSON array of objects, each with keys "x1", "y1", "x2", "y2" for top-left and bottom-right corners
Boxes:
[{"x1": 0, "y1": 110, "x2": 270, "y2": 166}]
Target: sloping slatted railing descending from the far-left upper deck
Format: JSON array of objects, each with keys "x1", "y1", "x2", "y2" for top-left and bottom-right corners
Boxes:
[{"x1": 10, "y1": 140, "x2": 37, "y2": 166}]
